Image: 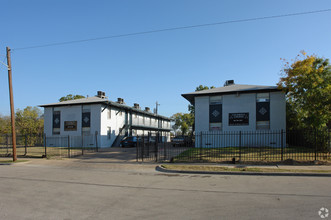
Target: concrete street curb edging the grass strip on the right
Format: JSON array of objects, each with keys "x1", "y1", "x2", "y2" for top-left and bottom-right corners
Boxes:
[{"x1": 155, "y1": 165, "x2": 331, "y2": 177}]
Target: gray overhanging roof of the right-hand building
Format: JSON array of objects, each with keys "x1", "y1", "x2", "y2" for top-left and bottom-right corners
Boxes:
[{"x1": 182, "y1": 84, "x2": 280, "y2": 104}]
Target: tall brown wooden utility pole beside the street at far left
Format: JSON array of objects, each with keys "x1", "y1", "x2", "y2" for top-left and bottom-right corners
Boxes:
[{"x1": 6, "y1": 47, "x2": 17, "y2": 162}]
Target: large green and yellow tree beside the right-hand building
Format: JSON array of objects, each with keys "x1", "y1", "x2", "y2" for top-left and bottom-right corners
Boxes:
[{"x1": 278, "y1": 52, "x2": 331, "y2": 129}]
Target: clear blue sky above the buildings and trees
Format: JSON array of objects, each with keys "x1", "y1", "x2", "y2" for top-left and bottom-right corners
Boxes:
[{"x1": 0, "y1": 0, "x2": 331, "y2": 116}]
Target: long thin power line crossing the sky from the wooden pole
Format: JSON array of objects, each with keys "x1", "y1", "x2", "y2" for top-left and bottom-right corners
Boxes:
[{"x1": 12, "y1": 9, "x2": 331, "y2": 50}]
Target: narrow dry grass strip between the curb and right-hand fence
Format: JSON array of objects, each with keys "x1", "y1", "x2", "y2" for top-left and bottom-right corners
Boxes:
[{"x1": 161, "y1": 164, "x2": 331, "y2": 173}]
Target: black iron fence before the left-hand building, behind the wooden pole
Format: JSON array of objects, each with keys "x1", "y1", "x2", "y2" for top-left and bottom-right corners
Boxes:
[{"x1": 0, "y1": 134, "x2": 98, "y2": 158}]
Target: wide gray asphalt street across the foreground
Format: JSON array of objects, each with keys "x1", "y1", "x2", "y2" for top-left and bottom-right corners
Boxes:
[{"x1": 0, "y1": 160, "x2": 331, "y2": 220}]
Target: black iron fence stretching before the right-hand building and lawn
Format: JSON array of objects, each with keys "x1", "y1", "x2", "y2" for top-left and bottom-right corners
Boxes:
[{"x1": 137, "y1": 130, "x2": 331, "y2": 162}]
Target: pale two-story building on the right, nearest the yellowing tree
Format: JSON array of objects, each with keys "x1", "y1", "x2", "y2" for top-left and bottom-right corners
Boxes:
[{"x1": 182, "y1": 80, "x2": 286, "y2": 147}]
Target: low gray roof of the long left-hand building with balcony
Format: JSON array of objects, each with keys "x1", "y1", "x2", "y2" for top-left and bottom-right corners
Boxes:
[{"x1": 39, "y1": 96, "x2": 170, "y2": 120}]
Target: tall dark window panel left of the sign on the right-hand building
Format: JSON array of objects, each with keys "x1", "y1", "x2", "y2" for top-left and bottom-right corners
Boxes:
[{"x1": 209, "y1": 96, "x2": 222, "y2": 131}]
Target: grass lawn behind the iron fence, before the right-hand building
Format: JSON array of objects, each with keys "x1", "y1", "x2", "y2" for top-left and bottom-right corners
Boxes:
[{"x1": 173, "y1": 147, "x2": 331, "y2": 162}]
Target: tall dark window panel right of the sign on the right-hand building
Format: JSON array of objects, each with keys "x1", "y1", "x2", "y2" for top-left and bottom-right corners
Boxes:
[{"x1": 256, "y1": 93, "x2": 270, "y2": 130}]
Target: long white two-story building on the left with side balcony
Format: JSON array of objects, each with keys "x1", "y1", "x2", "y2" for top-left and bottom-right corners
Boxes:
[{"x1": 40, "y1": 91, "x2": 170, "y2": 147}]
